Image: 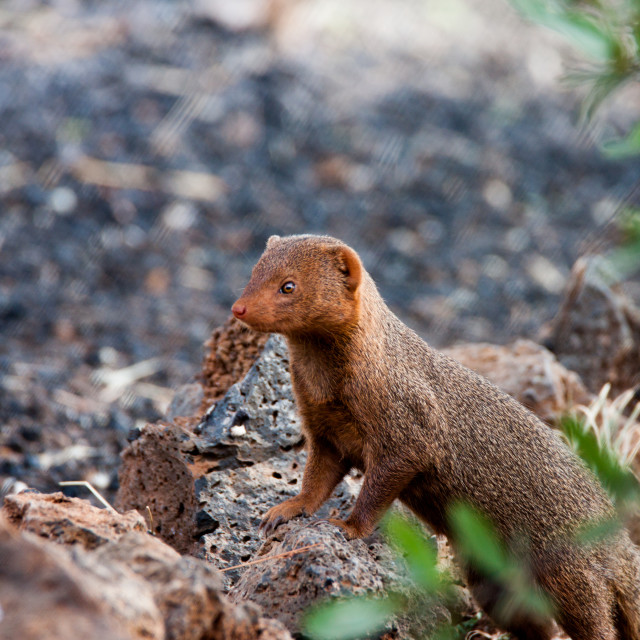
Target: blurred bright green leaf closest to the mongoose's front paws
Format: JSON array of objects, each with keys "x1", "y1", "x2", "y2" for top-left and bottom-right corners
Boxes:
[{"x1": 384, "y1": 513, "x2": 443, "y2": 593}]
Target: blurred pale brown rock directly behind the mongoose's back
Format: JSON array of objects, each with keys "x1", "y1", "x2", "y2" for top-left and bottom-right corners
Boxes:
[{"x1": 443, "y1": 340, "x2": 591, "y2": 422}]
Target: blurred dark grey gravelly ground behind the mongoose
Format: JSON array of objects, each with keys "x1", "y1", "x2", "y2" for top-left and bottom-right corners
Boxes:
[{"x1": 0, "y1": 0, "x2": 640, "y2": 494}]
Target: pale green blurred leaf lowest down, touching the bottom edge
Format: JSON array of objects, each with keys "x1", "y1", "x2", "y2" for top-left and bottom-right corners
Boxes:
[{"x1": 303, "y1": 596, "x2": 399, "y2": 640}]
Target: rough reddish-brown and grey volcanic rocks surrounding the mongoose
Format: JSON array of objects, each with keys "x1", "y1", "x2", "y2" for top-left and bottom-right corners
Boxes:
[{"x1": 0, "y1": 294, "x2": 640, "y2": 640}]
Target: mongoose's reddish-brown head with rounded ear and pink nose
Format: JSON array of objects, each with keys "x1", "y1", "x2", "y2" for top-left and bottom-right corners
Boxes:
[{"x1": 232, "y1": 235, "x2": 363, "y2": 336}]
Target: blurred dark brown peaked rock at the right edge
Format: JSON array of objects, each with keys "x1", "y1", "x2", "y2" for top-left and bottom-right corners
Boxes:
[{"x1": 547, "y1": 257, "x2": 640, "y2": 395}]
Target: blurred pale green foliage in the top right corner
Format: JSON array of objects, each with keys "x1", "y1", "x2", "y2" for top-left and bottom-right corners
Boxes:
[{"x1": 511, "y1": 0, "x2": 640, "y2": 158}]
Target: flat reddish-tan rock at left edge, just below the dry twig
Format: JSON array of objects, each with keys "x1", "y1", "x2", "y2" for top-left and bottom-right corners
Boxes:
[{"x1": 2, "y1": 491, "x2": 147, "y2": 549}]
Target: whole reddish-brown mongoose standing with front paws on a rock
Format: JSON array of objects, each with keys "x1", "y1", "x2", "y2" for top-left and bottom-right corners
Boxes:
[{"x1": 233, "y1": 236, "x2": 640, "y2": 640}]
